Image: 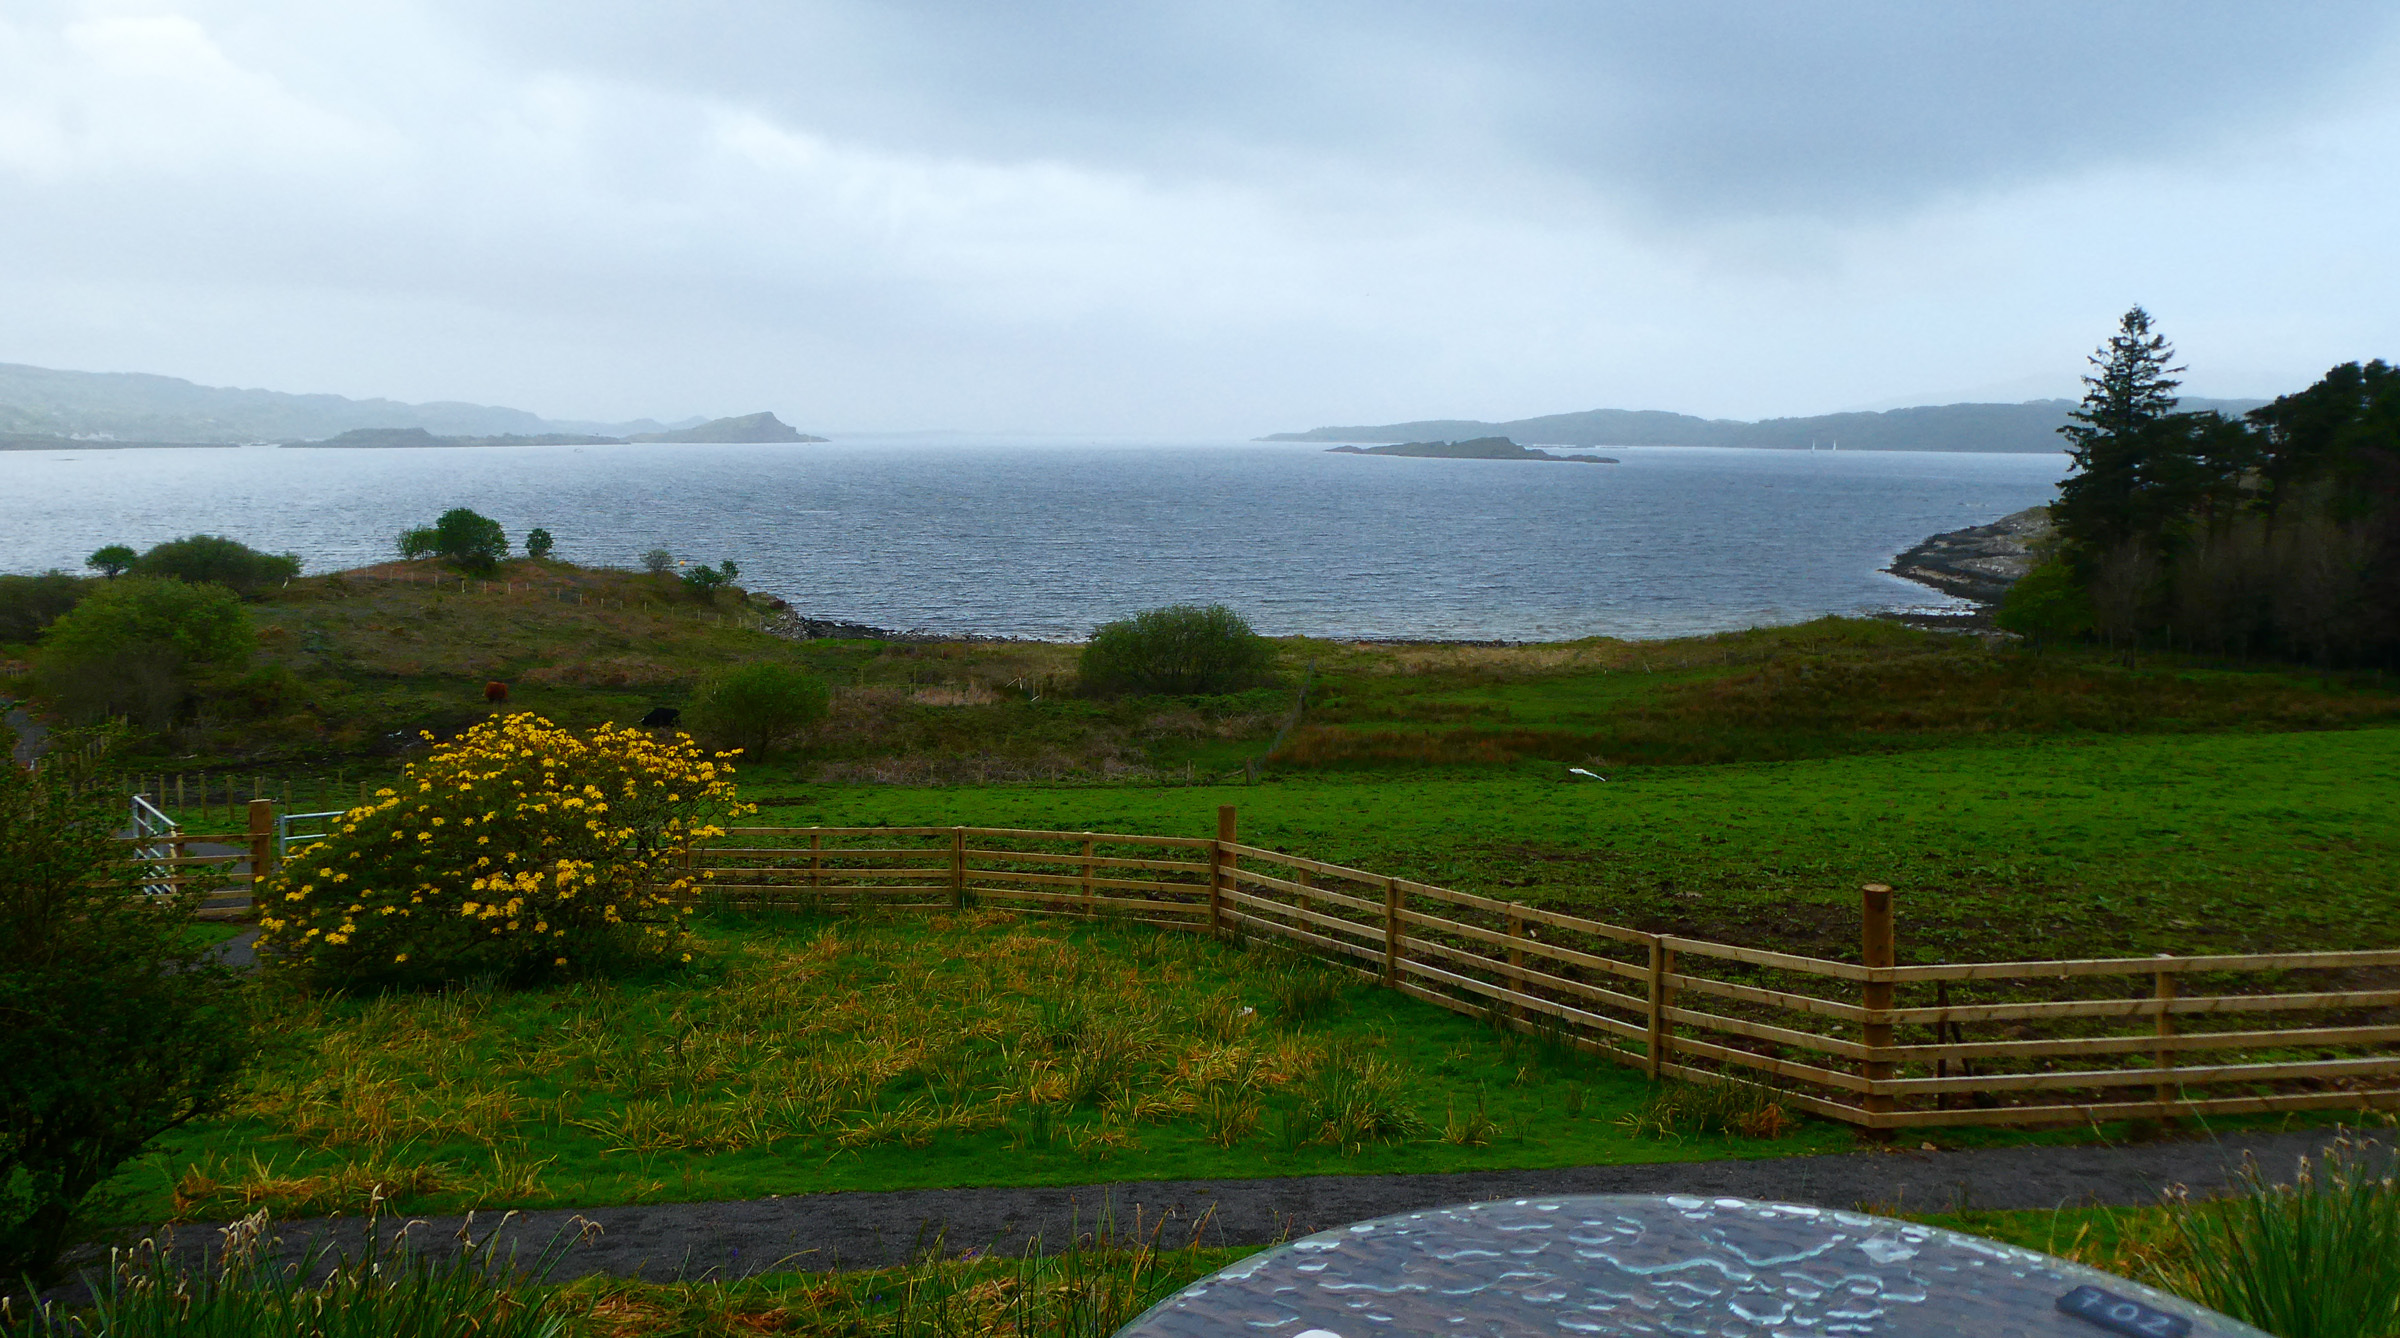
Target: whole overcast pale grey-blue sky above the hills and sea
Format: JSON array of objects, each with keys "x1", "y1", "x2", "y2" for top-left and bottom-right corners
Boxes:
[{"x1": 0, "y1": 0, "x2": 2400, "y2": 436}]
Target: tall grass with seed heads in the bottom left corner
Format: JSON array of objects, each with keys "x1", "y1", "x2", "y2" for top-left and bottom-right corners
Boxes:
[{"x1": 0, "y1": 1209, "x2": 574, "y2": 1338}]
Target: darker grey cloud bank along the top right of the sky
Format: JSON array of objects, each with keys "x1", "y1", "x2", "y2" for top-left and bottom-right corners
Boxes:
[{"x1": 432, "y1": 0, "x2": 2400, "y2": 218}]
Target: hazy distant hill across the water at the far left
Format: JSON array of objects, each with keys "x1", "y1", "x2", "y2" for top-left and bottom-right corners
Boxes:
[{"x1": 0, "y1": 362, "x2": 816, "y2": 446}]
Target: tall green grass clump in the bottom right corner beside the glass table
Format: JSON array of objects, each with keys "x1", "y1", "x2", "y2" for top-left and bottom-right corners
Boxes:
[{"x1": 2158, "y1": 1137, "x2": 2400, "y2": 1338}]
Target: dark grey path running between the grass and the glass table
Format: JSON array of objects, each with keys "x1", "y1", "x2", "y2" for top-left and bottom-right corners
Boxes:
[{"x1": 126, "y1": 1132, "x2": 2393, "y2": 1280}]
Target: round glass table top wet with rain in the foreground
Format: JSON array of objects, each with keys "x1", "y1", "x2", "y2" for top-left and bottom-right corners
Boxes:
[{"x1": 1118, "y1": 1194, "x2": 2263, "y2": 1338}]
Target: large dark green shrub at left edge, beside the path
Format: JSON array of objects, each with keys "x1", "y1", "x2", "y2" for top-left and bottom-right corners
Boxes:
[{"x1": 0, "y1": 734, "x2": 250, "y2": 1280}]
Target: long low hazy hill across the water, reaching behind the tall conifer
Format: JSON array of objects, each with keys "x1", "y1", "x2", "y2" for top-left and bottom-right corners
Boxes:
[{"x1": 1260, "y1": 398, "x2": 2266, "y2": 451}]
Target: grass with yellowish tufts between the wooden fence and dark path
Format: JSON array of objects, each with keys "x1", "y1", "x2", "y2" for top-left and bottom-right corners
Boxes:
[{"x1": 125, "y1": 911, "x2": 1853, "y2": 1221}]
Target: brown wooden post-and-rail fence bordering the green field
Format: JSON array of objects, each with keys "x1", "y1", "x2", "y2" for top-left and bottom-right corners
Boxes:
[{"x1": 136, "y1": 803, "x2": 2400, "y2": 1129}]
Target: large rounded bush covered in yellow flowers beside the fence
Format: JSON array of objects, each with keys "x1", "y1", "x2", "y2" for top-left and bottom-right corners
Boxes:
[{"x1": 259, "y1": 715, "x2": 744, "y2": 986}]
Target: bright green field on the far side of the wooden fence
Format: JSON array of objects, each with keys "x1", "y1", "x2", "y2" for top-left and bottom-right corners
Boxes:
[{"x1": 739, "y1": 729, "x2": 2400, "y2": 962}]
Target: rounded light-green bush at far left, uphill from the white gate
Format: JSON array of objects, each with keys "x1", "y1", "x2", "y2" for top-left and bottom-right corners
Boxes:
[{"x1": 36, "y1": 575, "x2": 257, "y2": 727}]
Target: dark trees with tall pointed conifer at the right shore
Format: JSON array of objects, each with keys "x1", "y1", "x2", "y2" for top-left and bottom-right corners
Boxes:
[{"x1": 1999, "y1": 307, "x2": 2400, "y2": 667}]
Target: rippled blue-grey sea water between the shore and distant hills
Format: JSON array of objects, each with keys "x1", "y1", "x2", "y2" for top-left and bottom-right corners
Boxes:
[{"x1": 0, "y1": 436, "x2": 2066, "y2": 640}]
